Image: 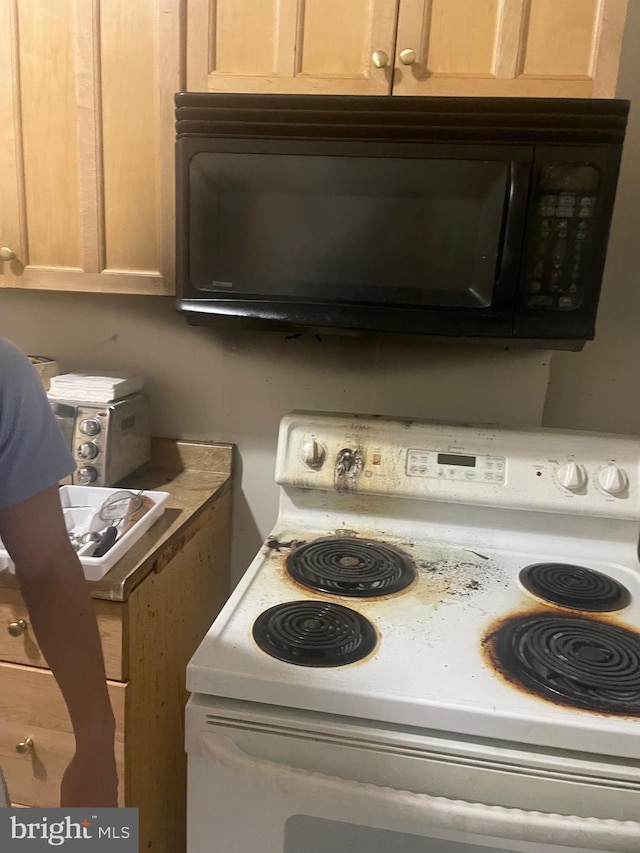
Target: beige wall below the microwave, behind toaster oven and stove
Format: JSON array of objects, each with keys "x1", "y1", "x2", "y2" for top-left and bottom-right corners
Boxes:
[{"x1": 0, "y1": 291, "x2": 549, "y2": 576}]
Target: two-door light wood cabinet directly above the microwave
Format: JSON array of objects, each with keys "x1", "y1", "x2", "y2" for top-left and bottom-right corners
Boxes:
[{"x1": 187, "y1": 0, "x2": 627, "y2": 97}]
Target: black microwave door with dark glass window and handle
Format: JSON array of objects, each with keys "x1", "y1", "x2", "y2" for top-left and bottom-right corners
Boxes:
[{"x1": 183, "y1": 145, "x2": 532, "y2": 336}]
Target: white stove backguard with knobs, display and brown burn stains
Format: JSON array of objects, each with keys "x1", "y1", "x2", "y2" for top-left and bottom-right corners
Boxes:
[{"x1": 276, "y1": 412, "x2": 640, "y2": 525}]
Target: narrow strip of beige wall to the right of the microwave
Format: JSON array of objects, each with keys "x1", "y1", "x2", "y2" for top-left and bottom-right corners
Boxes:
[{"x1": 544, "y1": 2, "x2": 640, "y2": 434}]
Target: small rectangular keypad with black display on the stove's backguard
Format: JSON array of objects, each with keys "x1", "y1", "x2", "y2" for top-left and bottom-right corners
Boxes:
[{"x1": 406, "y1": 448, "x2": 506, "y2": 486}]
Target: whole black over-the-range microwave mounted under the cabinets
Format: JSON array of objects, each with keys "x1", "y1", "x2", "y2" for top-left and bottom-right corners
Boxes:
[{"x1": 176, "y1": 93, "x2": 629, "y2": 350}]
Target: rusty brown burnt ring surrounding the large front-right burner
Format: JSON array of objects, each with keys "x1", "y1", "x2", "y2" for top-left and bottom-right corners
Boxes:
[{"x1": 480, "y1": 603, "x2": 640, "y2": 720}]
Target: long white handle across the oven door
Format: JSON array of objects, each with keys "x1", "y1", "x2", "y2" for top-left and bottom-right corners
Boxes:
[{"x1": 200, "y1": 732, "x2": 640, "y2": 853}]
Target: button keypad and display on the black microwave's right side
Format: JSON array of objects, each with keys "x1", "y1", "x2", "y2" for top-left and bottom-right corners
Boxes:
[{"x1": 526, "y1": 163, "x2": 600, "y2": 311}]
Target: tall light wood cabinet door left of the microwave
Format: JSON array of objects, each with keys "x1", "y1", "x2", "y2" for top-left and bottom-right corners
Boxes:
[{"x1": 0, "y1": 0, "x2": 180, "y2": 294}]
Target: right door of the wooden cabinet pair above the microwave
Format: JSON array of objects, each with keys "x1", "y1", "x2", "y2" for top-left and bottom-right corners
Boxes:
[{"x1": 393, "y1": 0, "x2": 627, "y2": 98}]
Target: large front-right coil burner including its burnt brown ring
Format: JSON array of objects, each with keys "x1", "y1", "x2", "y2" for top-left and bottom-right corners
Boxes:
[{"x1": 481, "y1": 607, "x2": 640, "y2": 718}]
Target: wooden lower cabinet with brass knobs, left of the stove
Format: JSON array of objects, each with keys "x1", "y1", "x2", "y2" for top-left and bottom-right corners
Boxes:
[{"x1": 0, "y1": 492, "x2": 230, "y2": 853}]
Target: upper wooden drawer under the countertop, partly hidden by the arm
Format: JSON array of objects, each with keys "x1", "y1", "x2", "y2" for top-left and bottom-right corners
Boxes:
[{"x1": 0, "y1": 589, "x2": 128, "y2": 681}]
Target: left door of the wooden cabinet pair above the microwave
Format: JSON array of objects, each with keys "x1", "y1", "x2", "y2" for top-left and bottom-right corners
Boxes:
[{"x1": 187, "y1": 0, "x2": 398, "y2": 95}]
